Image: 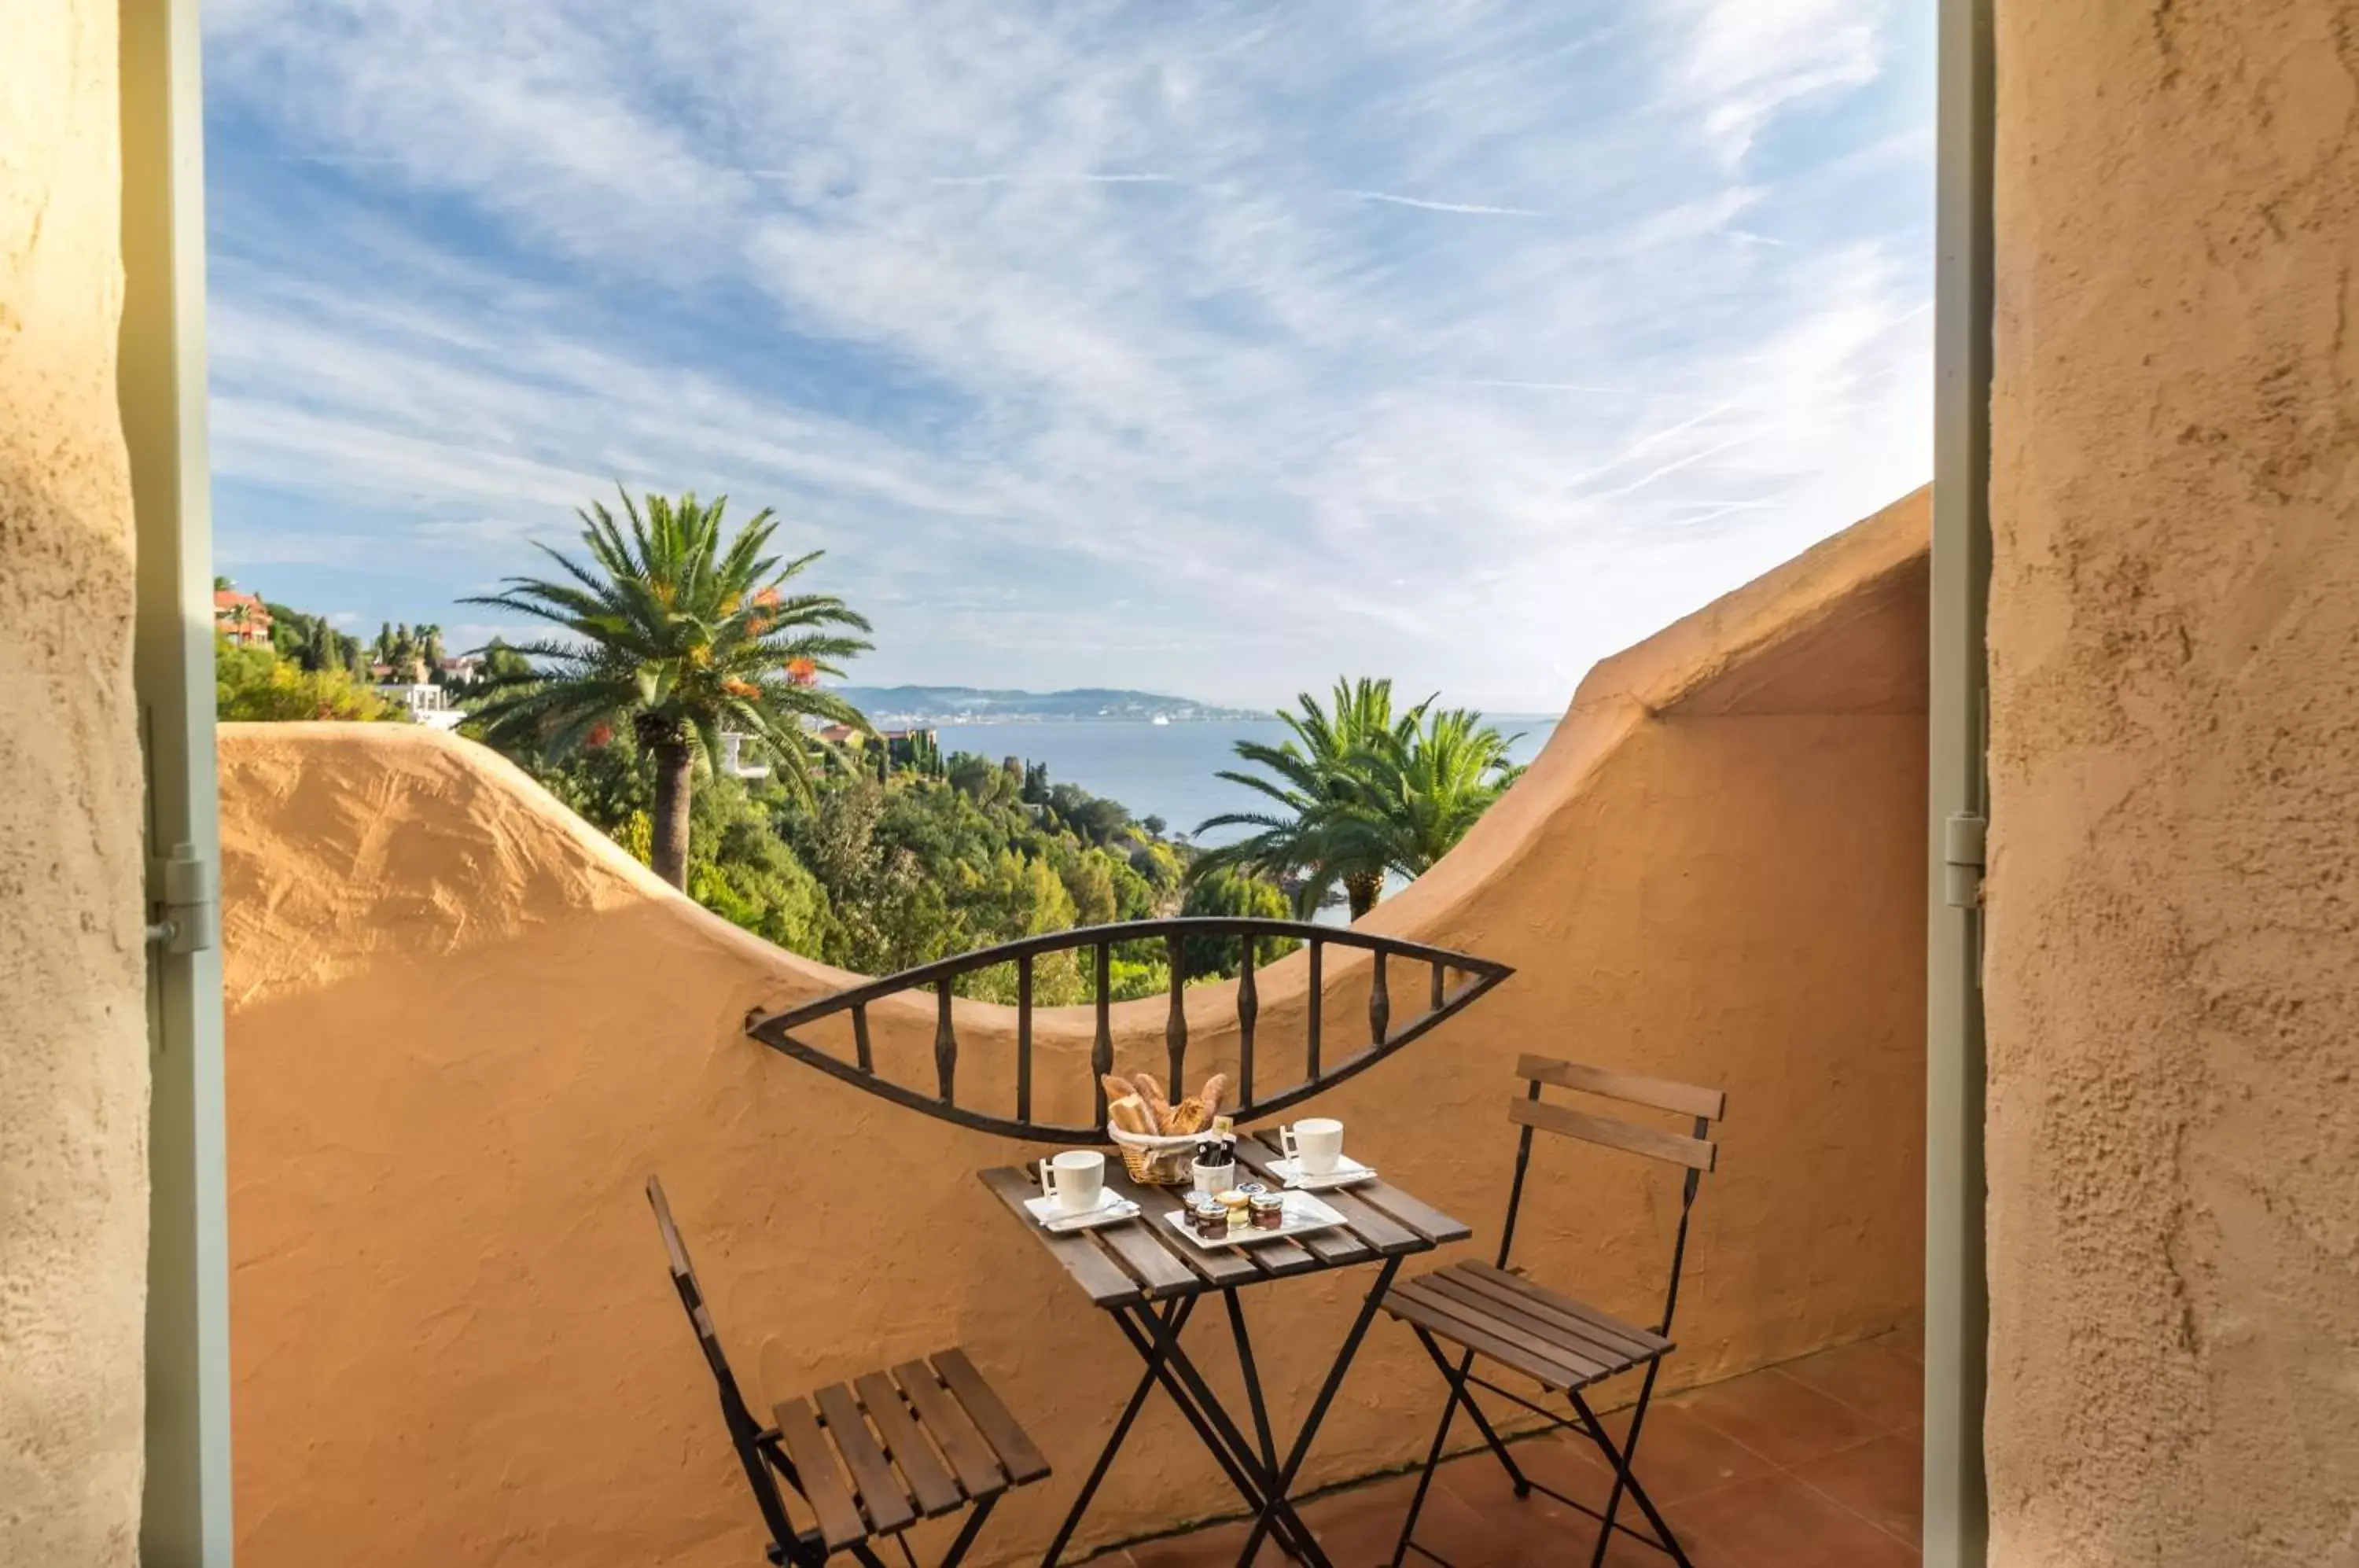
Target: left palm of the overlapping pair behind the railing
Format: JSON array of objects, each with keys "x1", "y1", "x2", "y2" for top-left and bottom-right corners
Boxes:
[{"x1": 1189, "y1": 679, "x2": 1425, "y2": 919}]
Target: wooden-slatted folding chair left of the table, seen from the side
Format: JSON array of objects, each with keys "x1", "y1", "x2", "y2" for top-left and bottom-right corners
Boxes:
[{"x1": 646, "y1": 1176, "x2": 1047, "y2": 1568}]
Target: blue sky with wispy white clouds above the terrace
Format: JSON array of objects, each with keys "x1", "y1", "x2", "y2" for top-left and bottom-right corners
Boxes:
[{"x1": 205, "y1": 0, "x2": 1932, "y2": 712}]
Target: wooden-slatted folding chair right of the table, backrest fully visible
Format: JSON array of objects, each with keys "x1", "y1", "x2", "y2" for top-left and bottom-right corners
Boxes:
[{"x1": 1385, "y1": 1056, "x2": 1727, "y2": 1568}]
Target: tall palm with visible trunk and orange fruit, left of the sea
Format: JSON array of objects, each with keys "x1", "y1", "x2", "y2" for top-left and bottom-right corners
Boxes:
[{"x1": 467, "y1": 493, "x2": 873, "y2": 886}]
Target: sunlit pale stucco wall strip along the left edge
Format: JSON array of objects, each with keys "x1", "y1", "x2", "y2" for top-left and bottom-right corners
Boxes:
[{"x1": 0, "y1": 0, "x2": 146, "y2": 1563}]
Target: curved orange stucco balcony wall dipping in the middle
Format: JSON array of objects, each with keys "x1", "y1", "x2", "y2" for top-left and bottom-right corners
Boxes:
[{"x1": 222, "y1": 483, "x2": 1925, "y2": 1568}]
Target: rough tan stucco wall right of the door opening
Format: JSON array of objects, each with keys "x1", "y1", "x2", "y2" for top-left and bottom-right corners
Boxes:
[{"x1": 1986, "y1": 0, "x2": 2359, "y2": 1568}]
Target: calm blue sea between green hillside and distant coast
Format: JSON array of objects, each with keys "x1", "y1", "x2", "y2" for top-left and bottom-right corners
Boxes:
[{"x1": 934, "y1": 715, "x2": 1557, "y2": 844}]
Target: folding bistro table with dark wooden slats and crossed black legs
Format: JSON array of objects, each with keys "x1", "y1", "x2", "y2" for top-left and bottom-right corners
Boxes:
[{"x1": 981, "y1": 1136, "x2": 1472, "y2": 1568}]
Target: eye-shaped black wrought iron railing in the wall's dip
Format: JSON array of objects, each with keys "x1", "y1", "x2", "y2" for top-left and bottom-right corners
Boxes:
[{"x1": 745, "y1": 917, "x2": 1514, "y2": 1143}]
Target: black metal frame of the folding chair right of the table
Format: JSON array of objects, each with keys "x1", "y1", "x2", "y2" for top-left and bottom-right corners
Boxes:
[{"x1": 1392, "y1": 1056, "x2": 1724, "y2": 1568}]
